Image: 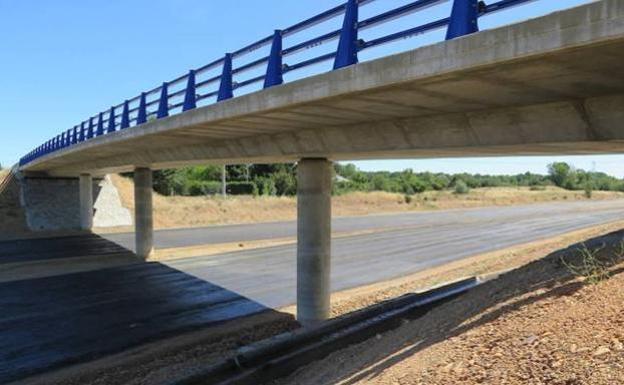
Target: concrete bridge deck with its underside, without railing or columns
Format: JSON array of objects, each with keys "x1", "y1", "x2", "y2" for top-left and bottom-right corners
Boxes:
[{"x1": 23, "y1": 0, "x2": 624, "y2": 176}]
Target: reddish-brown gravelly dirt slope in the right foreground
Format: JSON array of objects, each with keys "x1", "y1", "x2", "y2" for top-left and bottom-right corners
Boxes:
[{"x1": 274, "y1": 228, "x2": 624, "y2": 385}]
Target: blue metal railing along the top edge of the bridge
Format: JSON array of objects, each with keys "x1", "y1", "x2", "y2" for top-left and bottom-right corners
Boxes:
[{"x1": 20, "y1": 0, "x2": 536, "y2": 165}]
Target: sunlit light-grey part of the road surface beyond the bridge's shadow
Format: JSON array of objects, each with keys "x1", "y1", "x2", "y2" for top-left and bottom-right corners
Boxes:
[{"x1": 107, "y1": 200, "x2": 624, "y2": 307}]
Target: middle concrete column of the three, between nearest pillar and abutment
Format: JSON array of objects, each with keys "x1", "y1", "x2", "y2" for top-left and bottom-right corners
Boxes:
[{"x1": 134, "y1": 168, "x2": 154, "y2": 259}]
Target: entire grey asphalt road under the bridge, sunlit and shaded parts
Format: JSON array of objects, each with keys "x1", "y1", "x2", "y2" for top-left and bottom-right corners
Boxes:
[{"x1": 0, "y1": 200, "x2": 624, "y2": 383}]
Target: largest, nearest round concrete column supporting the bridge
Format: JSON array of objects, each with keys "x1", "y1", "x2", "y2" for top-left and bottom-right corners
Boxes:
[{"x1": 297, "y1": 159, "x2": 333, "y2": 326}]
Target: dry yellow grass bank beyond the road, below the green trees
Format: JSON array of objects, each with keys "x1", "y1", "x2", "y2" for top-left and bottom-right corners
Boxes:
[{"x1": 113, "y1": 176, "x2": 624, "y2": 228}]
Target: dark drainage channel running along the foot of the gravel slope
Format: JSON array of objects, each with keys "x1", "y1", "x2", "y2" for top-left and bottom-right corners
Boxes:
[{"x1": 175, "y1": 277, "x2": 483, "y2": 385}]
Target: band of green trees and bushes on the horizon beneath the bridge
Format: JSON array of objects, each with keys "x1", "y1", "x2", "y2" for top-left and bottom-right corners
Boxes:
[{"x1": 145, "y1": 163, "x2": 624, "y2": 196}]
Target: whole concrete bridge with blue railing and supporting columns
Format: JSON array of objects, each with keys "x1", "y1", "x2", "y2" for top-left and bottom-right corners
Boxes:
[{"x1": 13, "y1": 0, "x2": 624, "y2": 324}]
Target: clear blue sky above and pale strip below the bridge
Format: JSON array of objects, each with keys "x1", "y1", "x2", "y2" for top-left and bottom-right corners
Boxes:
[{"x1": 0, "y1": 0, "x2": 624, "y2": 177}]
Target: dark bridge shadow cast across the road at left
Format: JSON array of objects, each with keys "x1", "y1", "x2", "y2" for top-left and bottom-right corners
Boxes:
[{"x1": 0, "y1": 235, "x2": 292, "y2": 383}]
